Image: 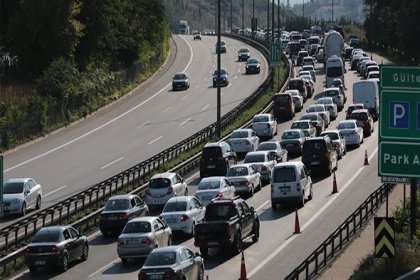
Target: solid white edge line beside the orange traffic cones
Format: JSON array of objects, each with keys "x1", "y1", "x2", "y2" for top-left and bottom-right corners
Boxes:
[{"x1": 248, "y1": 147, "x2": 378, "y2": 278}]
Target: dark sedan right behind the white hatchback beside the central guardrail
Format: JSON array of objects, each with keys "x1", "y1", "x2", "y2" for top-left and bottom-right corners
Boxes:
[{"x1": 99, "y1": 194, "x2": 149, "y2": 236}]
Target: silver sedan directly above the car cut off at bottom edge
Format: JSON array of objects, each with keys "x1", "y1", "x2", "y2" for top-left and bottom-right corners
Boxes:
[{"x1": 117, "y1": 217, "x2": 172, "y2": 263}]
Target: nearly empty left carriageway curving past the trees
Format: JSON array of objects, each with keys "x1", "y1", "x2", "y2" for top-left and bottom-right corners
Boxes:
[{"x1": 0, "y1": 35, "x2": 268, "y2": 227}]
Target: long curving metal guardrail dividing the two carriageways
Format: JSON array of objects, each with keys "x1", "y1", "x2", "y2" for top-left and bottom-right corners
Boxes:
[{"x1": 0, "y1": 35, "x2": 288, "y2": 275}]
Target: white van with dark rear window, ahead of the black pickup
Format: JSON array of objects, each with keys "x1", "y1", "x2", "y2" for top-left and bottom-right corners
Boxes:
[{"x1": 271, "y1": 161, "x2": 313, "y2": 210}]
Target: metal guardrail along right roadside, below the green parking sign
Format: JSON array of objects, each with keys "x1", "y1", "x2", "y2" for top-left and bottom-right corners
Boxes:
[{"x1": 285, "y1": 184, "x2": 395, "y2": 280}]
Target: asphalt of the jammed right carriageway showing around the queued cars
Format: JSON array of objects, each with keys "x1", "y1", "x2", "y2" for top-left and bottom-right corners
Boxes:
[{"x1": 8, "y1": 43, "x2": 387, "y2": 280}]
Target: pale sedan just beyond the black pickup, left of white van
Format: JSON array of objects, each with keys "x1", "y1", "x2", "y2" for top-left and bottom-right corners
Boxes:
[{"x1": 226, "y1": 164, "x2": 262, "y2": 196}]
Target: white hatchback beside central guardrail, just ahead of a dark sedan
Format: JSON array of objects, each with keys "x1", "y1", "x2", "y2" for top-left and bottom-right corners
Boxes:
[{"x1": 146, "y1": 172, "x2": 188, "y2": 206}]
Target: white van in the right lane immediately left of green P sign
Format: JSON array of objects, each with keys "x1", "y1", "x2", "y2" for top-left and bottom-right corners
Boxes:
[{"x1": 353, "y1": 80, "x2": 379, "y2": 121}]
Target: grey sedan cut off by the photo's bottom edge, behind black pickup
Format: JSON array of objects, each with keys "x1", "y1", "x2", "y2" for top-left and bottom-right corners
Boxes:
[{"x1": 137, "y1": 245, "x2": 205, "y2": 280}]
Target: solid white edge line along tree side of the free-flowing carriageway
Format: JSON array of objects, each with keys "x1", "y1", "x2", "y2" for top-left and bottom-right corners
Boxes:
[{"x1": 4, "y1": 36, "x2": 194, "y2": 172}]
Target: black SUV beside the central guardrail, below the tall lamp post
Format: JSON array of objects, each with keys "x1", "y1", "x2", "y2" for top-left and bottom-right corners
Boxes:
[{"x1": 200, "y1": 141, "x2": 237, "y2": 178}]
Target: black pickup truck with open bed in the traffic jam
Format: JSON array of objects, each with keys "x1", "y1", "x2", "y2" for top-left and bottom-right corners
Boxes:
[{"x1": 194, "y1": 197, "x2": 260, "y2": 257}]
